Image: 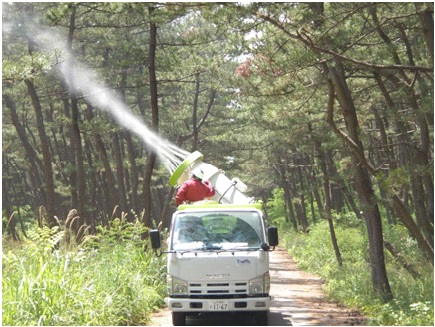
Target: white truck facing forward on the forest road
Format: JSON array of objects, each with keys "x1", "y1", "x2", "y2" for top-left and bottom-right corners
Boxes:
[{"x1": 150, "y1": 152, "x2": 278, "y2": 326}]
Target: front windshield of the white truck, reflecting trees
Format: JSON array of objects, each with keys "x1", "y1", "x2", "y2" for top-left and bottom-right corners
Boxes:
[{"x1": 172, "y1": 211, "x2": 263, "y2": 250}]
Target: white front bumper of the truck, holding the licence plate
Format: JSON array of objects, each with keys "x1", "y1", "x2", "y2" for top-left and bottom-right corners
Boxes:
[{"x1": 165, "y1": 296, "x2": 271, "y2": 312}]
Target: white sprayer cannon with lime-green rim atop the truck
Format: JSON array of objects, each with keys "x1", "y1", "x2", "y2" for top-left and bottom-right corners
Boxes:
[{"x1": 169, "y1": 151, "x2": 254, "y2": 204}]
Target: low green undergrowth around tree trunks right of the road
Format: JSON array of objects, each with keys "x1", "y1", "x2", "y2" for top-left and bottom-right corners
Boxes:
[{"x1": 280, "y1": 217, "x2": 434, "y2": 326}]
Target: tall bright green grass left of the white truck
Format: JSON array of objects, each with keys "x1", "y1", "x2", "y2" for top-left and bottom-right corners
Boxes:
[{"x1": 2, "y1": 219, "x2": 166, "y2": 326}]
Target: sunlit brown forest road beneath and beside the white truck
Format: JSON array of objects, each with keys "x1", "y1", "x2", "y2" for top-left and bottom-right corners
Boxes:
[{"x1": 151, "y1": 248, "x2": 364, "y2": 326}]
